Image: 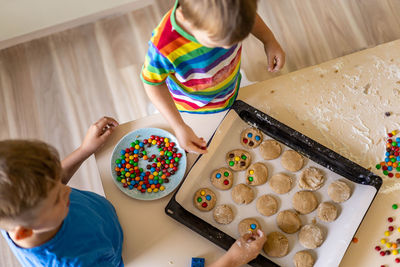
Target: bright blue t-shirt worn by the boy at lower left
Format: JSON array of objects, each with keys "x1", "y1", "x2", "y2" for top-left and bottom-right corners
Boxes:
[{"x1": 1, "y1": 188, "x2": 124, "y2": 267}]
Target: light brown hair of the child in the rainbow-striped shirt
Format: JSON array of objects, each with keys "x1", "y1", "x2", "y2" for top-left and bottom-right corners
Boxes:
[{"x1": 179, "y1": 0, "x2": 258, "y2": 45}]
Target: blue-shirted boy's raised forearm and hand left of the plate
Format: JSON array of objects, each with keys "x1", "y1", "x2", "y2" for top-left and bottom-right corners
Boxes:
[{"x1": 61, "y1": 117, "x2": 118, "y2": 184}]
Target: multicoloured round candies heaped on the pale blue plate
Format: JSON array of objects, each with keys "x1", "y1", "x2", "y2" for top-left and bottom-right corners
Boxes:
[{"x1": 114, "y1": 135, "x2": 182, "y2": 193}]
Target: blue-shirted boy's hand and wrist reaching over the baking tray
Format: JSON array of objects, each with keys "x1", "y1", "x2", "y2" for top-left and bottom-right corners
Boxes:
[{"x1": 209, "y1": 230, "x2": 267, "y2": 267}]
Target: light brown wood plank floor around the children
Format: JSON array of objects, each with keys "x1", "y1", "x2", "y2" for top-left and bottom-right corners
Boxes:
[{"x1": 0, "y1": 0, "x2": 400, "y2": 266}]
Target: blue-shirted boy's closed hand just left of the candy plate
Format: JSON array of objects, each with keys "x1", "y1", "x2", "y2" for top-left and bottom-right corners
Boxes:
[{"x1": 80, "y1": 117, "x2": 118, "y2": 155}]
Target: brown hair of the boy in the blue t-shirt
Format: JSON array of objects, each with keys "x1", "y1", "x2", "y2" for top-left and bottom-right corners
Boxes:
[{"x1": 0, "y1": 140, "x2": 61, "y2": 220}]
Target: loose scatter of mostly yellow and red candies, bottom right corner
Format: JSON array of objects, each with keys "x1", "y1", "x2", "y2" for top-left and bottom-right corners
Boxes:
[{"x1": 375, "y1": 204, "x2": 400, "y2": 266}]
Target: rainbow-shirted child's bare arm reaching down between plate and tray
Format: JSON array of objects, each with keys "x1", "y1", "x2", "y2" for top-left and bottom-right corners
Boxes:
[{"x1": 143, "y1": 83, "x2": 207, "y2": 154}]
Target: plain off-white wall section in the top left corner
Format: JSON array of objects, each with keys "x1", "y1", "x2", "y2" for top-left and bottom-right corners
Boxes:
[{"x1": 0, "y1": 0, "x2": 154, "y2": 49}]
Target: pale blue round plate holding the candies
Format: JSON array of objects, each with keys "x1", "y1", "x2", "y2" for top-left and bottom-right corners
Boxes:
[{"x1": 110, "y1": 128, "x2": 186, "y2": 200}]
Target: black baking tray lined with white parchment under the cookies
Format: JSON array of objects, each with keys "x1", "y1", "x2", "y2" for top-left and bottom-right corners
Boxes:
[{"x1": 165, "y1": 100, "x2": 382, "y2": 267}]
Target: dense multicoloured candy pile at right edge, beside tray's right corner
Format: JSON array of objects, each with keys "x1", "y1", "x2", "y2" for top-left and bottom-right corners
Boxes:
[{"x1": 375, "y1": 131, "x2": 400, "y2": 178}]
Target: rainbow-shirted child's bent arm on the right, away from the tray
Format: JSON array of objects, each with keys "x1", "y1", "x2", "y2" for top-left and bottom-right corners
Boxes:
[{"x1": 251, "y1": 14, "x2": 285, "y2": 72}]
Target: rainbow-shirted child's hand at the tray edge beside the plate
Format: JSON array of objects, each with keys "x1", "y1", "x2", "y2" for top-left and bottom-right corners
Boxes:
[{"x1": 175, "y1": 124, "x2": 207, "y2": 154}]
